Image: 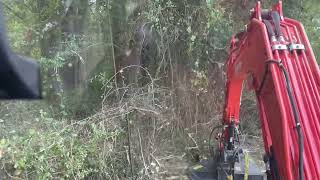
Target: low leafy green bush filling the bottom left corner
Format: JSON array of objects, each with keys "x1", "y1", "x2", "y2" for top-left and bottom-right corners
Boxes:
[{"x1": 0, "y1": 111, "x2": 127, "y2": 179}]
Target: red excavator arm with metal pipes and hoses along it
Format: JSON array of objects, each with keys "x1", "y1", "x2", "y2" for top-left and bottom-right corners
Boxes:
[{"x1": 220, "y1": 1, "x2": 320, "y2": 180}]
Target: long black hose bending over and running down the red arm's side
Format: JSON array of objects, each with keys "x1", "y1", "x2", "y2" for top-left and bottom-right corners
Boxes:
[{"x1": 257, "y1": 60, "x2": 304, "y2": 180}]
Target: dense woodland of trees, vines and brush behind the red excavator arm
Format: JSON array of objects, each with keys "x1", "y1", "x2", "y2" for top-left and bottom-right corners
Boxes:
[{"x1": 0, "y1": 0, "x2": 320, "y2": 179}]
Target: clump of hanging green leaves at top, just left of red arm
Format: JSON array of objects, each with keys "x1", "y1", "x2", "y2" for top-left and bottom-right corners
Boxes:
[{"x1": 142, "y1": 0, "x2": 233, "y2": 71}]
